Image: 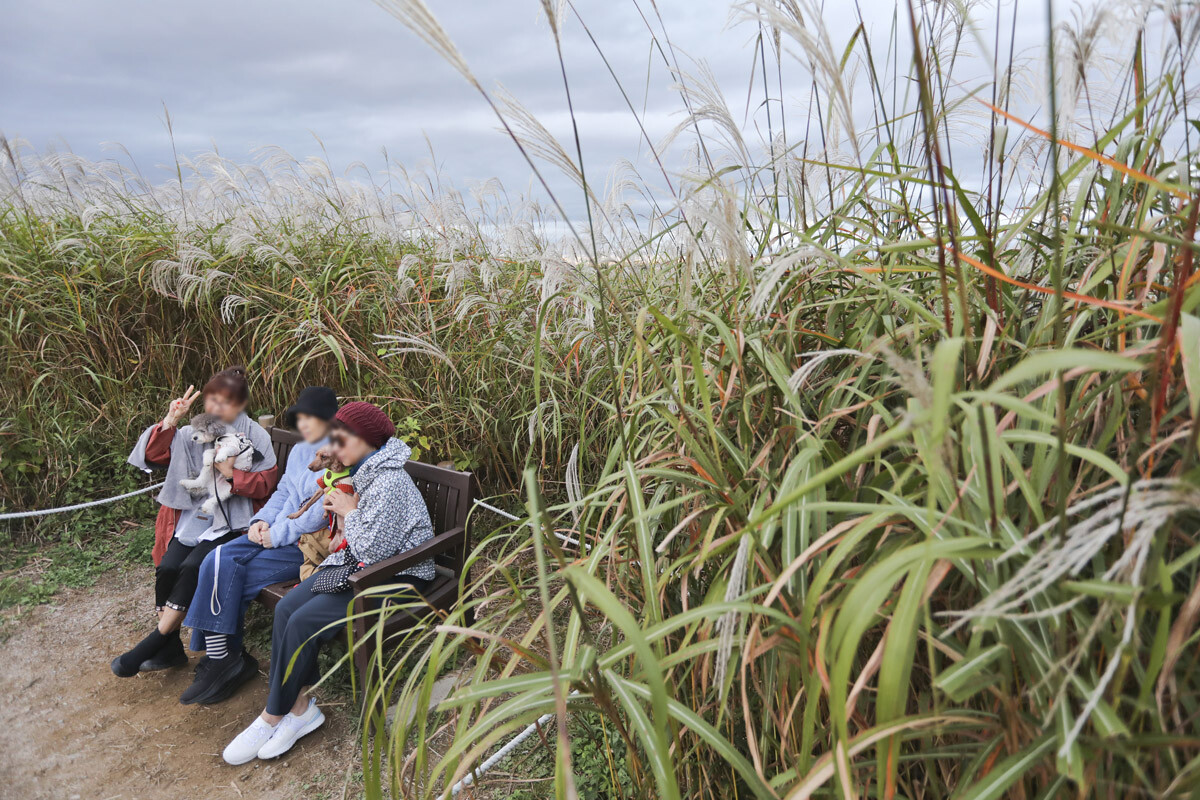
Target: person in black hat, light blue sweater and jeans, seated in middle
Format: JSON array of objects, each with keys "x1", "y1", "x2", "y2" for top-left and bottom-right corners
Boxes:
[{"x1": 179, "y1": 386, "x2": 337, "y2": 705}]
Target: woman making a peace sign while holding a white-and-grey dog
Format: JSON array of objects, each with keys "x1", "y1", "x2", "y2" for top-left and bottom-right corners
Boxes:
[{"x1": 112, "y1": 367, "x2": 278, "y2": 678}]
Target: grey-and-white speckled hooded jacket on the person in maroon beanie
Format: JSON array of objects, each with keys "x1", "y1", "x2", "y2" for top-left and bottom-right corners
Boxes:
[{"x1": 322, "y1": 438, "x2": 434, "y2": 581}]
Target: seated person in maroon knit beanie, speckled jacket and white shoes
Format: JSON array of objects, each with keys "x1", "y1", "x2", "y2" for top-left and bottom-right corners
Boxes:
[{"x1": 222, "y1": 402, "x2": 434, "y2": 764}]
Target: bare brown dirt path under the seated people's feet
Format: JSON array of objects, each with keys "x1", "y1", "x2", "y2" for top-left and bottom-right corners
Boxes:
[{"x1": 0, "y1": 569, "x2": 359, "y2": 800}]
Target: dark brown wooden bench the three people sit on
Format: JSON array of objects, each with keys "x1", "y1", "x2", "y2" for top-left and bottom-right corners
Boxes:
[{"x1": 258, "y1": 420, "x2": 474, "y2": 681}]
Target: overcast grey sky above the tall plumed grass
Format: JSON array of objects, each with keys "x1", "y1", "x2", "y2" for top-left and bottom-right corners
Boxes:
[{"x1": 0, "y1": 0, "x2": 1089, "y2": 212}]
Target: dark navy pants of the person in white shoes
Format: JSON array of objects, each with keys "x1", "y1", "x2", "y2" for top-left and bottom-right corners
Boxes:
[{"x1": 266, "y1": 570, "x2": 431, "y2": 716}]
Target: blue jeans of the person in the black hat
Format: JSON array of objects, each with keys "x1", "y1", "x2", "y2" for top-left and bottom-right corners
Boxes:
[{"x1": 184, "y1": 536, "x2": 304, "y2": 652}]
